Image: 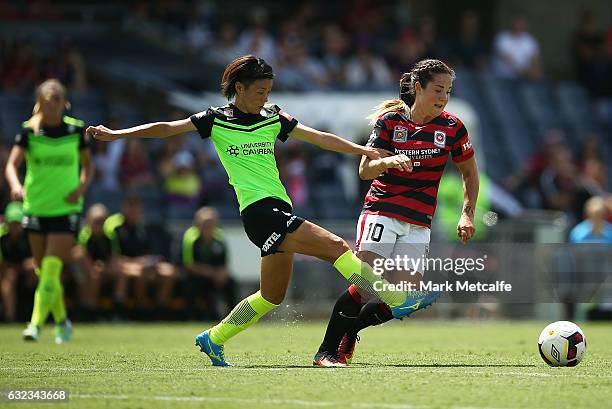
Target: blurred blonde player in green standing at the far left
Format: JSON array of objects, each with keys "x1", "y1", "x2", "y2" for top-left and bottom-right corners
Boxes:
[{"x1": 5, "y1": 79, "x2": 93, "y2": 343}]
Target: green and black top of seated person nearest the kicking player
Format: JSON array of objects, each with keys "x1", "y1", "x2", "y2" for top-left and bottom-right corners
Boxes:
[{"x1": 182, "y1": 226, "x2": 227, "y2": 267}]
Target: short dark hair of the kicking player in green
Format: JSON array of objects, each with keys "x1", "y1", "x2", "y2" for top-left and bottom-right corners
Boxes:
[{"x1": 221, "y1": 55, "x2": 274, "y2": 100}]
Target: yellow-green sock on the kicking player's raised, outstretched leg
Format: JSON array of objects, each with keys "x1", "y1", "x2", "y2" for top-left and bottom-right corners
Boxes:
[{"x1": 334, "y1": 250, "x2": 406, "y2": 307}]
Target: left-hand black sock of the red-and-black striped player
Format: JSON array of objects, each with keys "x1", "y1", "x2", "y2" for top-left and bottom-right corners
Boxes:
[{"x1": 319, "y1": 291, "x2": 362, "y2": 355}]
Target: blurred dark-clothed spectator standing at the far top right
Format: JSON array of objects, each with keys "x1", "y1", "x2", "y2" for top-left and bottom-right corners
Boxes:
[{"x1": 572, "y1": 11, "x2": 604, "y2": 95}]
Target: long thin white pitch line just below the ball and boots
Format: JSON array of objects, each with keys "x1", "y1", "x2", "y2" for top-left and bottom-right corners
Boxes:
[{"x1": 0, "y1": 366, "x2": 612, "y2": 378}]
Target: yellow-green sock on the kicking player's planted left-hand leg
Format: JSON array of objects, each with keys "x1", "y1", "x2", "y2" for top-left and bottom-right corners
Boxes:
[{"x1": 209, "y1": 291, "x2": 278, "y2": 345}]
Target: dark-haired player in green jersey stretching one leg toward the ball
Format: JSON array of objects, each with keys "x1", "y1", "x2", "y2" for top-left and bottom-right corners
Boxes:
[{"x1": 87, "y1": 55, "x2": 426, "y2": 366}]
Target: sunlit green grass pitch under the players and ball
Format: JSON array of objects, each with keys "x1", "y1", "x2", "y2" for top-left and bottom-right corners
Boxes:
[{"x1": 0, "y1": 319, "x2": 612, "y2": 409}]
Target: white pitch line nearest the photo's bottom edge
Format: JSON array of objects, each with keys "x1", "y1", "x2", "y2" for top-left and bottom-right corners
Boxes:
[{"x1": 70, "y1": 394, "x2": 512, "y2": 409}]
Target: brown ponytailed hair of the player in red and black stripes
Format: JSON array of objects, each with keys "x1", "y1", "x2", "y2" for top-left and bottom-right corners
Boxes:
[{"x1": 367, "y1": 59, "x2": 455, "y2": 123}]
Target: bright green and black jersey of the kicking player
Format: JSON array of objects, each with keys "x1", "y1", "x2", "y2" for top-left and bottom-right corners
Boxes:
[{"x1": 191, "y1": 104, "x2": 298, "y2": 212}]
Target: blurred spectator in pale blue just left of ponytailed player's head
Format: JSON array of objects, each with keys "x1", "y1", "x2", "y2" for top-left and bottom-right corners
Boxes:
[{"x1": 346, "y1": 43, "x2": 394, "y2": 91}]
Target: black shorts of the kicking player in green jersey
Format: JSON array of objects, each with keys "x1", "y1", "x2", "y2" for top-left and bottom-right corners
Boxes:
[{"x1": 240, "y1": 197, "x2": 304, "y2": 257}]
